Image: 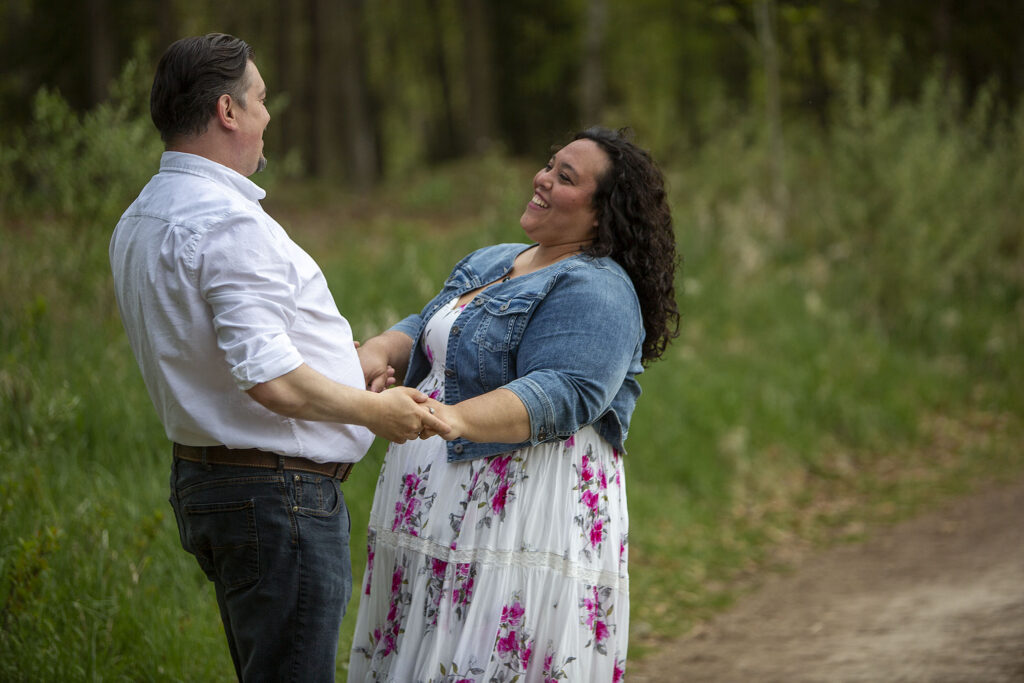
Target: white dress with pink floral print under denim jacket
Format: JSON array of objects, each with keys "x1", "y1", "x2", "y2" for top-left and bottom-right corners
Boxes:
[{"x1": 348, "y1": 301, "x2": 629, "y2": 683}]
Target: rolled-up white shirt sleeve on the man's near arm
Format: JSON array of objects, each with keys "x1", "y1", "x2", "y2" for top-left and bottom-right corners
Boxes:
[{"x1": 195, "y1": 219, "x2": 303, "y2": 390}]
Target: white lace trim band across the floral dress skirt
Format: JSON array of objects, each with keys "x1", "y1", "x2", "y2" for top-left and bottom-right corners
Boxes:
[{"x1": 374, "y1": 529, "x2": 630, "y2": 595}]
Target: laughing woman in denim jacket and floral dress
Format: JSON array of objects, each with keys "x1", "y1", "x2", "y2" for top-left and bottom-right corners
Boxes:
[{"x1": 348, "y1": 129, "x2": 679, "y2": 682}]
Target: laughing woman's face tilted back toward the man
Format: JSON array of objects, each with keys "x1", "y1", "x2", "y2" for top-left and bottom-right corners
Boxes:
[{"x1": 519, "y1": 139, "x2": 610, "y2": 247}]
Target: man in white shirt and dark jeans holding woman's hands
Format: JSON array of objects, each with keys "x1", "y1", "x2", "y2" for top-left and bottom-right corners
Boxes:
[{"x1": 110, "y1": 34, "x2": 447, "y2": 682}]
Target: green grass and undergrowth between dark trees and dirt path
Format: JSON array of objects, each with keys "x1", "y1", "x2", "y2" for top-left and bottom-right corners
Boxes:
[{"x1": 0, "y1": 60, "x2": 1024, "y2": 681}]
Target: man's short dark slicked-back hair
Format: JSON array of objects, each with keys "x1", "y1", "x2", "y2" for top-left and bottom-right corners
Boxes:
[{"x1": 150, "y1": 33, "x2": 253, "y2": 144}]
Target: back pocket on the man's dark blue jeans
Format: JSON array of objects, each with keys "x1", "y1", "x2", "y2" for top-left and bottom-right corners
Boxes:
[{"x1": 183, "y1": 500, "x2": 259, "y2": 588}]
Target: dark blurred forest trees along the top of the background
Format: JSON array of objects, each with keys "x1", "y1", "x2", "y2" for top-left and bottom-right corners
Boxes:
[{"x1": 0, "y1": 0, "x2": 1024, "y2": 185}]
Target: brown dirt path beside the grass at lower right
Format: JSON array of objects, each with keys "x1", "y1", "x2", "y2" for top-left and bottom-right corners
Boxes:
[{"x1": 627, "y1": 481, "x2": 1024, "y2": 683}]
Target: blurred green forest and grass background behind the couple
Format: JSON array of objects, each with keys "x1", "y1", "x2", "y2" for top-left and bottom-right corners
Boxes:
[{"x1": 0, "y1": 0, "x2": 1024, "y2": 681}]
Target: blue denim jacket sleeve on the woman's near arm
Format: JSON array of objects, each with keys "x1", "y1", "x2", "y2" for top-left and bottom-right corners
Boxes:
[{"x1": 497, "y1": 273, "x2": 643, "y2": 444}]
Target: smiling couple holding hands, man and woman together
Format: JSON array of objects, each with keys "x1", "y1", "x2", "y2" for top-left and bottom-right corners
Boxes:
[{"x1": 110, "y1": 34, "x2": 679, "y2": 682}]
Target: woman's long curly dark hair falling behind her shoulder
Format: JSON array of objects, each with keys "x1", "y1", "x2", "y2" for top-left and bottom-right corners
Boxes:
[{"x1": 572, "y1": 128, "x2": 679, "y2": 366}]
